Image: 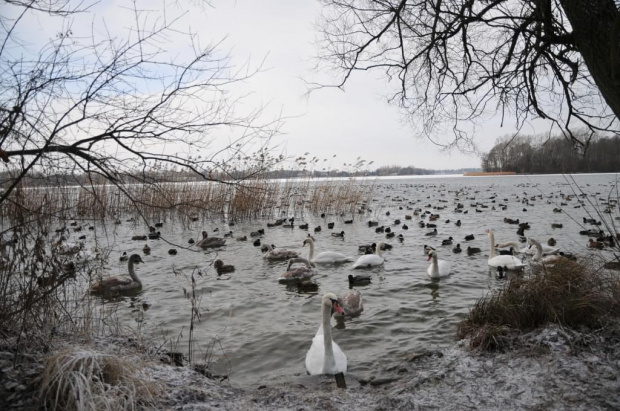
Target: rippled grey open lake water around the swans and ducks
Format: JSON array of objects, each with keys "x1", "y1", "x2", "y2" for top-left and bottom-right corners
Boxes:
[{"x1": 94, "y1": 174, "x2": 620, "y2": 385}]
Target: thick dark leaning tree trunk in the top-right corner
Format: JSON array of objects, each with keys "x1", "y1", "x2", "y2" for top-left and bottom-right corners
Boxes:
[{"x1": 560, "y1": 0, "x2": 620, "y2": 118}]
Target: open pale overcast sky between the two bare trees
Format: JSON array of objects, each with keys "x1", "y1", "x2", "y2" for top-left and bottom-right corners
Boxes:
[{"x1": 18, "y1": 0, "x2": 542, "y2": 169}]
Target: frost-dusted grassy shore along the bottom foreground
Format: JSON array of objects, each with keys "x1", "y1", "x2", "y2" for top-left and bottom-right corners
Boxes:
[{"x1": 0, "y1": 323, "x2": 620, "y2": 411}]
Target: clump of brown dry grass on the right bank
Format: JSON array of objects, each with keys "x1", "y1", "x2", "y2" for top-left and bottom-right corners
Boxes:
[{"x1": 457, "y1": 260, "x2": 620, "y2": 350}]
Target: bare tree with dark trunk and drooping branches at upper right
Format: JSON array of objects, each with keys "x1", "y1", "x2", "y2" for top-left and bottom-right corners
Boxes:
[{"x1": 319, "y1": 0, "x2": 620, "y2": 149}]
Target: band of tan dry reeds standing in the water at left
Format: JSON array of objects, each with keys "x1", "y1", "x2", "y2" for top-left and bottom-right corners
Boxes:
[{"x1": 0, "y1": 175, "x2": 372, "y2": 227}]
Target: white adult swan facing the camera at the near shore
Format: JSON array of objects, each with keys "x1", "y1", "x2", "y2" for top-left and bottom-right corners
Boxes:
[{"x1": 306, "y1": 293, "x2": 347, "y2": 375}]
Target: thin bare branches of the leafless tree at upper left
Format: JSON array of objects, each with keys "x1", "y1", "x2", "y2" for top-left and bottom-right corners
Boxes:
[{"x1": 0, "y1": 0, "x2": 279, "y2": 209}]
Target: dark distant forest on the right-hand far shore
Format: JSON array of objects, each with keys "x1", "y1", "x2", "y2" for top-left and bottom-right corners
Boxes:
[{"x1": 482, "y1": 135, "x2": 620, "y2": 174}]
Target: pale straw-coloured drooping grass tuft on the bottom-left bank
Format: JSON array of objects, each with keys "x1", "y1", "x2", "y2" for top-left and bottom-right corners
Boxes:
[{"x1": 41, "y1": 349, "x2": 162, "y2": 410}]
